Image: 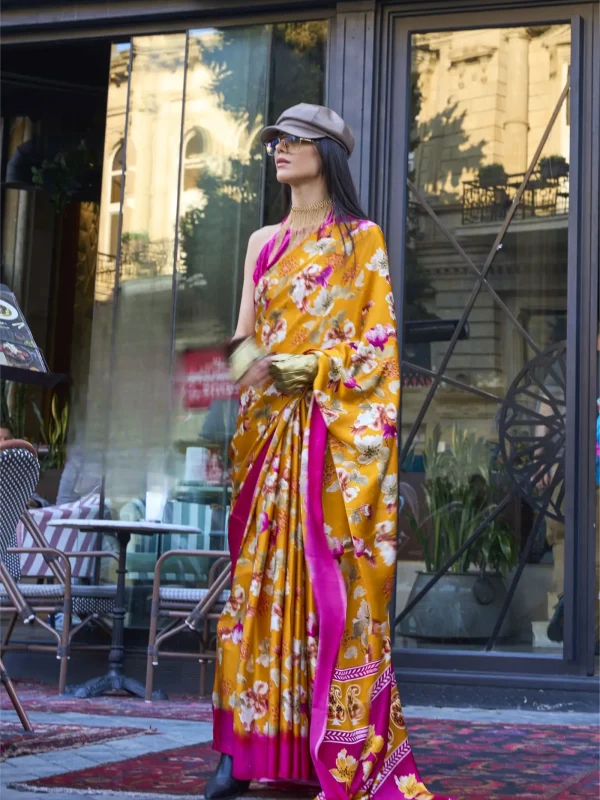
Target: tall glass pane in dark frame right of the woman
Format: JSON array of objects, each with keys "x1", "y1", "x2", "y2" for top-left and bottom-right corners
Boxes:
[{"x1": 397, "y1": 25, "x2": 570, "y2": 654}]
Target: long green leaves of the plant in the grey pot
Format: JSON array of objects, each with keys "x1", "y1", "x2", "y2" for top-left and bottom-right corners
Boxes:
[{"x1": 409, "y1": 424, "x2": 518, "y2": 575}]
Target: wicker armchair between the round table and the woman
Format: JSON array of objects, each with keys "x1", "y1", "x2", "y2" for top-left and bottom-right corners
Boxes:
[{"x1": 146, "y1": 550, "x2": 231, "y2": 700}]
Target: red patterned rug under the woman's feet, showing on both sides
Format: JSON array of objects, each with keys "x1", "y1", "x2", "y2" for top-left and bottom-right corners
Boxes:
[{"x1": 10, "y1": 720, "x2": 600, "y2": 800}]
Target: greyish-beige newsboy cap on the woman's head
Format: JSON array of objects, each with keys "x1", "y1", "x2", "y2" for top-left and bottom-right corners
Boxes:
[{"x1": 260, "y1": 103, "x2": 354, "y2": 156}]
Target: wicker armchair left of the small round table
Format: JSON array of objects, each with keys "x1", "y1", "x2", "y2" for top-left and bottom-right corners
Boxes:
[{"x1": 0, "y1": 442, "x2": 117, "y2": 694}]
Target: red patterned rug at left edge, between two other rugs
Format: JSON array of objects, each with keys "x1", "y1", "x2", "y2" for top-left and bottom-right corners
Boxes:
[{"x1": 0, "y1": 722, "x2": 156, "y2": 761}]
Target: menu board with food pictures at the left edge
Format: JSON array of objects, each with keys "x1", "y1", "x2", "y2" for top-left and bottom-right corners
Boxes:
[{"x1": 0, "y1": 283, "x2": 48, "y2": 372}]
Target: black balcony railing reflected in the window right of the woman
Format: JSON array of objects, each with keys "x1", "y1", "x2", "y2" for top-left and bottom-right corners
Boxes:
[{"x1": 462, "y1": 168, "x2": 569, "y2": 225}]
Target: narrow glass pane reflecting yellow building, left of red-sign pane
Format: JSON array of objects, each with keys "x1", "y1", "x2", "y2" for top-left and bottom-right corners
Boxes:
[{"x1": 106, "y1": 34, "x2": 185, "y2": 517}]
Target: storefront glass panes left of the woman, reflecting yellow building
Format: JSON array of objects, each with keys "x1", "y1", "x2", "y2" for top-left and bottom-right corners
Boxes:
[{"x1": 86, "y1": 22, "x2": 328, "y2": 625}]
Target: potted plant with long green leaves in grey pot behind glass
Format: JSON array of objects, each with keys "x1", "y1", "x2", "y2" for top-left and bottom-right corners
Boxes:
[{"x1": 400, "y1": 425, "x2": 518, "y2": 642}]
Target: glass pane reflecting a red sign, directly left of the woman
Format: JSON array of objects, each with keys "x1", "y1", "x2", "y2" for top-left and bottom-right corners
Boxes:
[{"x1": 171, "y1": 26, "x2": 271, "y2": 585}]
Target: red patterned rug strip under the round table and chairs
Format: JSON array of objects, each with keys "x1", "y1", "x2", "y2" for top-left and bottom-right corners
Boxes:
[{"x1": 0, "y1": 681, "x2": 212, "y2": 722}]
